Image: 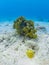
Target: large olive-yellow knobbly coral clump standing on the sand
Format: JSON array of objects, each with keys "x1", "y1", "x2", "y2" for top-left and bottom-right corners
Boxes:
[{"x1": 13, "y1": 16, "x2": 37, "y2": 39}]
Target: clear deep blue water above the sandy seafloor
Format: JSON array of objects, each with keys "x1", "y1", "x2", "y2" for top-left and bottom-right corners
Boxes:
[{"x1": 0, "y1": 0, "x2": 49, "y2": 20}]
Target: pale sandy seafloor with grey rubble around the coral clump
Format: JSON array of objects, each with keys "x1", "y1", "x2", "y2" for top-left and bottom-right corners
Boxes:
[{"x1": 0, "y1": 21, "x2": 49, "y2": 65}]
